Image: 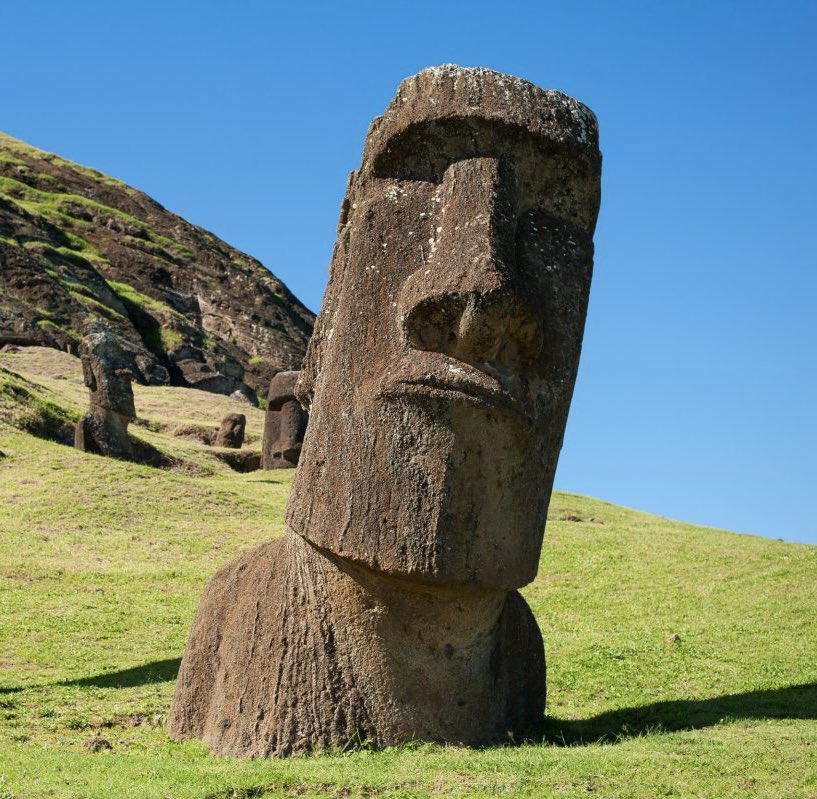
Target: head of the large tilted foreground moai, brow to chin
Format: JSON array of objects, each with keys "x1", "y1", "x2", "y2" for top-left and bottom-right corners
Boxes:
[{"x1": 288, "y1": 67, "x2": 600, "y2": 589}]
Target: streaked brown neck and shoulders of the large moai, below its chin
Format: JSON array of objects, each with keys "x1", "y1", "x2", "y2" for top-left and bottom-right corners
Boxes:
[{"x1": 168, "y1": 531, "x2": 545, "y2": 757}]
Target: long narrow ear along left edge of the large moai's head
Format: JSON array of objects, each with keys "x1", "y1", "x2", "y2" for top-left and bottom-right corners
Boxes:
[{"x1": 295, "y1": 171, "x2": 358, "y2": 411}]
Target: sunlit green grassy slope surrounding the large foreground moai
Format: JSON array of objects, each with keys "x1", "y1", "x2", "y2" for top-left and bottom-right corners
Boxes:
[{"x1": 0, "y1": 350, "x2": 817, "y2": 799}]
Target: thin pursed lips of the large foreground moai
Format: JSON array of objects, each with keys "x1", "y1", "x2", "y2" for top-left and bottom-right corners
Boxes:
[{"x1": 380, "y1": 352, "x2": 534, "y2": 425}]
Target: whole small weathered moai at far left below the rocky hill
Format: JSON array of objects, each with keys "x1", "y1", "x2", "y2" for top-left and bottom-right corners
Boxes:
[{"x1": 74, "y1": 331, "x2": 136, "y2": 460}]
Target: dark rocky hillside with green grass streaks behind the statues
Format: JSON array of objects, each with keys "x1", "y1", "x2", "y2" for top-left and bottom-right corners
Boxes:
[{"x1": 0, "y1": 134, "x2": 314, "y2": 404}]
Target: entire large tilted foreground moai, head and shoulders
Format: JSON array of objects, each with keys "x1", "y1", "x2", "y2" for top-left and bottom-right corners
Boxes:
[{"x1": 168, "y1": 66, "x2": 601, "y2": 756}]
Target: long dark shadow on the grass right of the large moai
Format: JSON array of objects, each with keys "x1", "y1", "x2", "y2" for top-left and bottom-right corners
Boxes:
[{"x1": 535, "y1": 683, "x2": 817, "y2": 746}]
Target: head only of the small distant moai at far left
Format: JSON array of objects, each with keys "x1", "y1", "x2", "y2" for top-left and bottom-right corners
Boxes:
[{"x1": 80, "y1": 331, "x2": 136, "y2": 419}]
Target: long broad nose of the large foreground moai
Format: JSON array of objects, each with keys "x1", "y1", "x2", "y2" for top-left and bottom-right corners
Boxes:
[{"x1": 400, "y1": 158, "x2": 542, "y2": 374}]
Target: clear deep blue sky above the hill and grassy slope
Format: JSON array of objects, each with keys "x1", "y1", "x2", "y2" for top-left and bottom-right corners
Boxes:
[{"x1": 0, "y1": 0, "x2": 817, "y2": 544}]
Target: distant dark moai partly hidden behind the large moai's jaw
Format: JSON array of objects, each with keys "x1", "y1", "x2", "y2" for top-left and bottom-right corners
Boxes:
[{"x1": 261, "y1": 372, "x2": 309, "y2": 469}]
